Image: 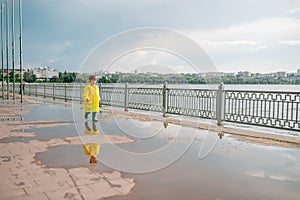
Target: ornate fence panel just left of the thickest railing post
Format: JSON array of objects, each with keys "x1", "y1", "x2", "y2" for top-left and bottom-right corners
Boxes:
[{"x1": 167, "y1": 89, "x2": 217, "y2": 119}]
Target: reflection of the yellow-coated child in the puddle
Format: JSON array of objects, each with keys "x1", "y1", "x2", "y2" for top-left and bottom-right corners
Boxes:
[{"x1": 83, "y1": 121, "x2": 100, "y2": 164}]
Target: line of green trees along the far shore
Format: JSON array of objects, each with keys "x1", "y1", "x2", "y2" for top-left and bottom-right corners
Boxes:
[{"x1": 0, "y1": 71, "x2": 300, "y2": 84}]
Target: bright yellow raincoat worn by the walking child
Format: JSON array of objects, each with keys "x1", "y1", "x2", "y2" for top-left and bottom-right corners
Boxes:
[{"x1": 83, "y1": 84, "x2": 100, "y2": 112}]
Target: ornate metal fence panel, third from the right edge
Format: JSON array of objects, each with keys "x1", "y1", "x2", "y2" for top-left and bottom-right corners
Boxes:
[{"x1": 127, "y1": 88, "x2": 163, "y2": 112}]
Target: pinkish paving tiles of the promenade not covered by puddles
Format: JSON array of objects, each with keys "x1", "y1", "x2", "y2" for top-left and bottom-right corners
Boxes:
[{"x1": 0, "y1": 100, "x2": 135, "y2": 200}]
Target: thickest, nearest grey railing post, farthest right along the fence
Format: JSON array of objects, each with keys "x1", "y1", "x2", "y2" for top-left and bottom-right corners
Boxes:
[{"x1": 216, "y1": 83, "x2": 225, "y2": 126}]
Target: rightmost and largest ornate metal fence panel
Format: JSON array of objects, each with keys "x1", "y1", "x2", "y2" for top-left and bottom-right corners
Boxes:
[{"x1": 225, "y1": 90, "x2": 300, "y2": 131}]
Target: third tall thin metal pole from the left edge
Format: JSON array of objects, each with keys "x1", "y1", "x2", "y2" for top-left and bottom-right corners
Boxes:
[{"x1": 11, "y1": 0, "x2": 16, "y2": 100}]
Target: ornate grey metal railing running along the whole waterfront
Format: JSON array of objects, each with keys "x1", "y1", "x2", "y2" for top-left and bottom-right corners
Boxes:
[{"x1": 0, "y1": 83, "x2": 300, "y2": 131}]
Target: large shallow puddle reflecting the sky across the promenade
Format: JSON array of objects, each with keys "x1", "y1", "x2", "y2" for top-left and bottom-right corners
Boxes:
[{"x1": 37, "y1": 115, "x2": 300, "y2": 200}]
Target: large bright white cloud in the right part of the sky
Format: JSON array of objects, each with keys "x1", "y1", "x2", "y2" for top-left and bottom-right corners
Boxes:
[{"x1": 187, "y1": 18, "x2": 300, "y2": 48}]
